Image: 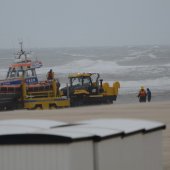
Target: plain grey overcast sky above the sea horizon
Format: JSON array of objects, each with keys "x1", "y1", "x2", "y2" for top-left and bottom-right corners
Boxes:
[{"x1": 0, "y1": 0, "x2": 170, "y2": 48}]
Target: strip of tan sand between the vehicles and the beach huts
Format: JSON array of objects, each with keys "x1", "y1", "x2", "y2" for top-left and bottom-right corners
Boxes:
[{"x1": 0, "y1": 100, "x2": 170, "y2": 170}]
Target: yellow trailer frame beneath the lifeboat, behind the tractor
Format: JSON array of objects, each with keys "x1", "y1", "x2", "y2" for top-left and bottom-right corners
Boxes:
[{"x1": 21, "y1": 80, "x2": 70, "y2": 109}]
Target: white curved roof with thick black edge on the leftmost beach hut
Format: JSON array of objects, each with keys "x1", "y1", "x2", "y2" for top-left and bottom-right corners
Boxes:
[{"x1": 0, "y1": 119, "x2": 93, "y2": 144}]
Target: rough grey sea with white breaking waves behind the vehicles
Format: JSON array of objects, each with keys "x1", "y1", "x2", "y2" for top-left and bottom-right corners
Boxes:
[{"x1": 0, "y1": 45, "x2": 170, "y2": 103}]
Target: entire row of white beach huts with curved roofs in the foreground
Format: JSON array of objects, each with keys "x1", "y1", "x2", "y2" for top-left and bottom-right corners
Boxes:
[{"x1": 0, "y1": 119, "x2": 165, "y2": 170}]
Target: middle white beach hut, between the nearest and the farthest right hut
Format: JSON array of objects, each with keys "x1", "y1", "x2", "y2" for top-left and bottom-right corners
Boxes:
[{"x1": 50, "y1": 124, "x2": 123, "y2": 170}]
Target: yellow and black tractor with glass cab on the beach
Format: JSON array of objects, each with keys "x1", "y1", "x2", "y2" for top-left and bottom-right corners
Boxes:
[{"x1": 61, "y1": 73, "x2": 120, "y2": 106}]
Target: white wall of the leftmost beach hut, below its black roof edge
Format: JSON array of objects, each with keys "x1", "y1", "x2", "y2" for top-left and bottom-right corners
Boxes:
[{"x1": 0, "y1": 142, "x2": 93, "y2": 170}]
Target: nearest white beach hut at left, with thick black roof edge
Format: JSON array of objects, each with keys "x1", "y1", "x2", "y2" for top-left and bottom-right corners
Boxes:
[{"x1": 0, "y1": 120, "x2": 93, "y2": 170}]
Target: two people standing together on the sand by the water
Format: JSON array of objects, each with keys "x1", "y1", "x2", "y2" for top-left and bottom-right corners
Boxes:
[{"x1": 138, "y1": 86, "x2": 152, "y2": 102}]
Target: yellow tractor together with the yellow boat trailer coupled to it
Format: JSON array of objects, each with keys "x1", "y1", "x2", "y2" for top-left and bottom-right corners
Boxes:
[{"x1": 8, "y1": 73, "x2": 120, "y2": 109}]
